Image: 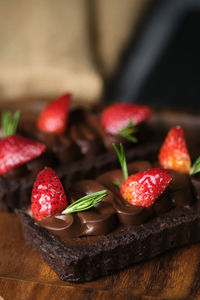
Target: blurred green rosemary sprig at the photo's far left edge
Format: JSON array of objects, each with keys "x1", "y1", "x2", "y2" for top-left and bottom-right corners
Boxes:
[{"x1": 2, "y1": 110, "x2": 21, "y2": 137}]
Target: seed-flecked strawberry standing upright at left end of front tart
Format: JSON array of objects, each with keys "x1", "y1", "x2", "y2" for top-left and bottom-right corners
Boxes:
[{"x1": 31, "y1": 168, "x2": 67, "y2": 221}]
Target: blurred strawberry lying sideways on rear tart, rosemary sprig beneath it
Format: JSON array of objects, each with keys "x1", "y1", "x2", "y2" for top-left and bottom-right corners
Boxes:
[{"x1": 101, "y1": 103, "x2": 152, "y2": 135}]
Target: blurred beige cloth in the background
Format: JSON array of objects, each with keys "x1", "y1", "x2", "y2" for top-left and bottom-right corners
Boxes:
[{"x1": 0, "y1": 0, "x2": 151, "y2": 101}]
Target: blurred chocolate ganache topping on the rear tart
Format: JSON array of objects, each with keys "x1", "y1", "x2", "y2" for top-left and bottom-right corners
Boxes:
[{"x1": 19, "y1": 106, "x2": 157, "y2": 165}]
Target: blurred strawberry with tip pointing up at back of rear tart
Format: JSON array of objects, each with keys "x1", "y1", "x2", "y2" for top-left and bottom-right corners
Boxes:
[{"x1": 37, "y1": 94, "x2": 71, "y2": 134}]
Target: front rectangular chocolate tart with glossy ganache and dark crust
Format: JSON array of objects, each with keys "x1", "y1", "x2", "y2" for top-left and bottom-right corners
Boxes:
[{"x1": 17, "y1": 161, "x2": 200, "y2": 282}]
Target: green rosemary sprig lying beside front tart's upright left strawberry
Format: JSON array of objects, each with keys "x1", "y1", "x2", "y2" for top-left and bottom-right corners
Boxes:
[{"x1": 61, "y1": 190, "x2": 109, "y2": 214}]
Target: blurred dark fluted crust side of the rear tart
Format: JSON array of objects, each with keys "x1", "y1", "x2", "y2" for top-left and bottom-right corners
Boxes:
[{"x1": 0, "y1": 142, "x2": 159, "y2": 212}]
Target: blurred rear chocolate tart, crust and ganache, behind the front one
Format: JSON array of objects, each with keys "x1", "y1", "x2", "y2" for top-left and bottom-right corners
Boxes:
[{"x1": 0, "y1": 107, "x2": 159, "y2": 211}]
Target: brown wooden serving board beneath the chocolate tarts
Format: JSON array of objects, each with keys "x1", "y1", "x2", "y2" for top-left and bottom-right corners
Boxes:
[{"x1": 0, "y1": 104, "x2": 200, "y2": 300}]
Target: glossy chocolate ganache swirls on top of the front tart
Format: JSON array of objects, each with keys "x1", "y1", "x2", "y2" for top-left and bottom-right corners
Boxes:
[{"x1": 35, "y1": 161, "x2": 197, "y2": 238}]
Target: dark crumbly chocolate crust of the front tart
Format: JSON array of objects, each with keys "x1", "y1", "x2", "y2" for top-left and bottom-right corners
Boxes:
[{"x1": 16, "y1": 209, "x2": 200, "y2": 283}]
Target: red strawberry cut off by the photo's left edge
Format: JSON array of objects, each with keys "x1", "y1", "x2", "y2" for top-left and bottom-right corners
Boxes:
[{"x1": 0, "y1": 135, "x2": 46, "y2": 175}]
